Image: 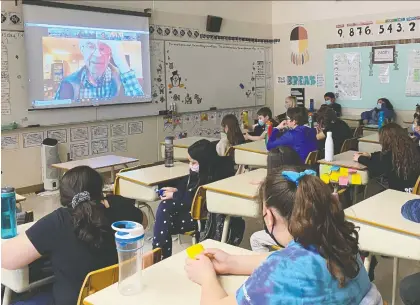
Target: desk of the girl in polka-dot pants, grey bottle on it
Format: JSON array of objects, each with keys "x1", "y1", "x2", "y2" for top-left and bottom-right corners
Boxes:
[{"x1": 114, "y1": 162, "x2": 190, "y2": 202}]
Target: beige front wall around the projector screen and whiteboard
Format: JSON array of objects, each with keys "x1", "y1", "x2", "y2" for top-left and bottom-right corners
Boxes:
[{"x1": 1, "y1": 1, "x2": 273, "y2": 188}]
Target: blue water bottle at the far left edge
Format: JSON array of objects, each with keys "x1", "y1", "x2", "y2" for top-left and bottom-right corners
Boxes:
[{"x1": 1, "y1": 187, "x2": 17, "y2": 239}]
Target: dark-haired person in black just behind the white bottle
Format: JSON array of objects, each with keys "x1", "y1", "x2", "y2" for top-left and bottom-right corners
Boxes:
[{"x1": 316, "y1": 107, "x2": 353, "y2": 157}]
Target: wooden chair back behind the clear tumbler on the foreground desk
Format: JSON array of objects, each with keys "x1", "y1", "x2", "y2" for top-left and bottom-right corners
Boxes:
[{"x1": 77, "y1": 248, "x2": 162, "y2": 305}]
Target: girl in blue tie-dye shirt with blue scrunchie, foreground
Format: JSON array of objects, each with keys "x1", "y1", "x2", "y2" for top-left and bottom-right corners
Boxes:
[{"x1": 185, "y1": 167, "x2": 372, "y2": 305}]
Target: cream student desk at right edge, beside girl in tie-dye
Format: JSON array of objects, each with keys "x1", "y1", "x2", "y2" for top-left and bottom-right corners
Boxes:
[{"x1": 345, "y1": 190, "x2": 420, "y2": 305}]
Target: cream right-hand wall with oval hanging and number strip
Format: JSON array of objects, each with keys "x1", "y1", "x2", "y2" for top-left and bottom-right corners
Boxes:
[{"x1": 272, "y1": 1, "x2": 420, "y2": 122}]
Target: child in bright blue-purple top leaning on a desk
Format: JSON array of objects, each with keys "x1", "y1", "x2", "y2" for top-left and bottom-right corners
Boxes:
[{"x1": 267, "y1": 107, "x2": 318, "y2": 162}]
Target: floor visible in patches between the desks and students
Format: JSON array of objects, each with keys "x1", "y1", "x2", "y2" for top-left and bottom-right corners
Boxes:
[{"x1": 22, "y1": 194, "x2": 420, "y2": 305}]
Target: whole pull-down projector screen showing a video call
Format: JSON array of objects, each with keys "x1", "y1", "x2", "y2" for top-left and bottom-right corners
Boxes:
[{"x1": 23, "y1": 1, "x2": 152, "y2": 110}]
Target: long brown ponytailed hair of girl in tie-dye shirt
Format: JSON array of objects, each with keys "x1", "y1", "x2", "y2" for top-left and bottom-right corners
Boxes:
[{"x1": 259, "y1": 167, "x2": 360, "y2": 287}]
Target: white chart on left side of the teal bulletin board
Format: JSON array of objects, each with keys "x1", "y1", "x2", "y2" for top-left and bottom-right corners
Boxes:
[{"x1": 333, "y1": 52, "x2": 362, "y2": 100}]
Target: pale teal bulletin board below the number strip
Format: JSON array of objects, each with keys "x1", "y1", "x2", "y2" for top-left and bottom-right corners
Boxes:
[{"x1": 326, "y1": 43, "x2": 420, "y2": 110}]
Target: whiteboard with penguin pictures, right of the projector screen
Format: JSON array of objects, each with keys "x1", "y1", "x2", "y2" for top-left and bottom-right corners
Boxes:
[{"x1": 165, "y1": 41, "x2": 266, "y2": 112}]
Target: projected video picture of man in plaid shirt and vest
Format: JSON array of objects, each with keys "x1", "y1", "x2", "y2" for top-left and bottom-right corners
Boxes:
[{"x1": 38, "y1": 28, "x2": 144, "y2": 108}]
